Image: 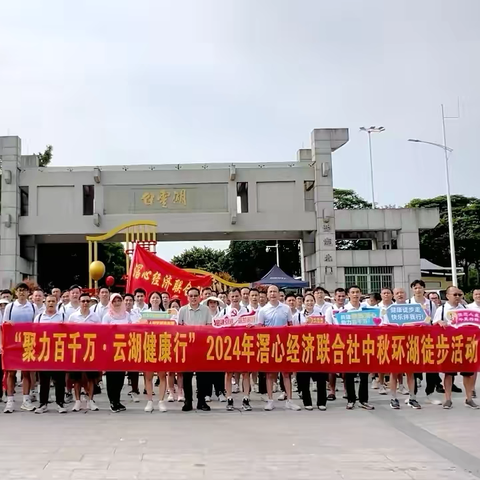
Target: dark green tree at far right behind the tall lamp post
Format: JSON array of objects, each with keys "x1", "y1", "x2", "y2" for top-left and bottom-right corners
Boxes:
[{"x1": 406, "y1": 195, "x2": 480, "y2": 288}]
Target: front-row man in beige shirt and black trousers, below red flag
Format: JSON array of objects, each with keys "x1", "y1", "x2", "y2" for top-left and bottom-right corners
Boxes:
[{"x1": 178, "y1": 287, "x2": 212, "y2": 412}]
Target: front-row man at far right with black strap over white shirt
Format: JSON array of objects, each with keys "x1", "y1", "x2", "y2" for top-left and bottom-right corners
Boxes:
[{"x1": 433, "y1": 285, "x2": 479, "y2": 410}]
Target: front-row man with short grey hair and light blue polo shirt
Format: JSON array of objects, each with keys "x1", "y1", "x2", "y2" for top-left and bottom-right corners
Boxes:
[{"x1": 258, "y1": 285, "x2": 301, "y2": 411}]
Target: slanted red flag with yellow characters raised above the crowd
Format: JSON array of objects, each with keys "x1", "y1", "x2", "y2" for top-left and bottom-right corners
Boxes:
[{"x1": 127, "y1": 243, "x2": 212, "y2": 306}]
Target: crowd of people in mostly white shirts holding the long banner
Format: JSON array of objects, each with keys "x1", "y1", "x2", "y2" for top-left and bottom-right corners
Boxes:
[{"x1": 0, "y1": 280, "x2": 480, "y2": 414}]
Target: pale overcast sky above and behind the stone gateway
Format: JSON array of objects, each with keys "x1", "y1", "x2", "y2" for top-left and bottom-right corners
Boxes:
[{"x1": 0, "y1": 0, "x2": 480, "y2": 258}]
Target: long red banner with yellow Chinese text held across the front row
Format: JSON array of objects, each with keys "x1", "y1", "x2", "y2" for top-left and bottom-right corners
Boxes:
[{"x1": 3, "y1": 323, "x2": 480, "y2": 373}]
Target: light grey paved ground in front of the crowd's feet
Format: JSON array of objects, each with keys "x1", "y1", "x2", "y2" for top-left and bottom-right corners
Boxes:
[{"x1": 0, "y1": 380, "x2": 480, "y2": 480}]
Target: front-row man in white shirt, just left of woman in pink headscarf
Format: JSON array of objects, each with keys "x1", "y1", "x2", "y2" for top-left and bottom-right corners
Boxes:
[{"x1": 65, "y1": 291, "x2": 102, "y2": 412}]
